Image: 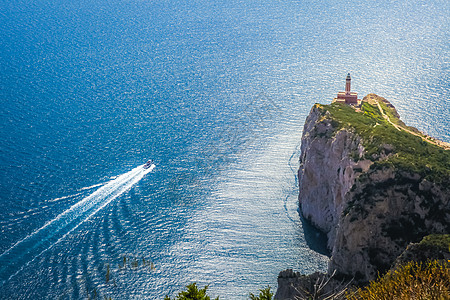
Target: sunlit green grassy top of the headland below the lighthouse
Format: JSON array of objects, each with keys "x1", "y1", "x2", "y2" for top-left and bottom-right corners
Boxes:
[{"x1": 316, "y1": 96, "x2": 450, "y2": 182}]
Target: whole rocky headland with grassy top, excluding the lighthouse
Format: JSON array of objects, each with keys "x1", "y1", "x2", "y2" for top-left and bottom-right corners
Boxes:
[{"x1": 299, "y1": 95, "x2": 450, "y2": 282}]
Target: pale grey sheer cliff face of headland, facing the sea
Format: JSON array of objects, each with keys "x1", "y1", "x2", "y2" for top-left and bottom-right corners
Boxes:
[{"x1": 298, "y1": 105, "x2": 372, "y2": 248}]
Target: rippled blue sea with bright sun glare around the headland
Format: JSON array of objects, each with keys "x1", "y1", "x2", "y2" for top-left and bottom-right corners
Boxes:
[{"x1": 0, "y1": 0, "x2": 450, "y2": 299}]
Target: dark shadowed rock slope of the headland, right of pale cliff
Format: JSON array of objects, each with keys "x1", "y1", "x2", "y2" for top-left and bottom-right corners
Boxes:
[{"x1": 329, "y1": 168, "x2": 450, "y2": 281}]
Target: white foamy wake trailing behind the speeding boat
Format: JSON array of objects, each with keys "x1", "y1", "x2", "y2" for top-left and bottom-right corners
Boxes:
[{"x1": 0, "y1": 164, "x2": 155, "y2": 286}]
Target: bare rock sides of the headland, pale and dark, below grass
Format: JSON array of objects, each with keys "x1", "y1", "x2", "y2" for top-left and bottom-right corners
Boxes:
[{"x1": 299, "y1": 95, "x2": 450, "y2": 282}]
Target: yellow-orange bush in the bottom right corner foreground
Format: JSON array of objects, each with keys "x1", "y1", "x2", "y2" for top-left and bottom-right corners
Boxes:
[{"x1": 347, "y1": 260, "x2": 450, "y2": 300}]
